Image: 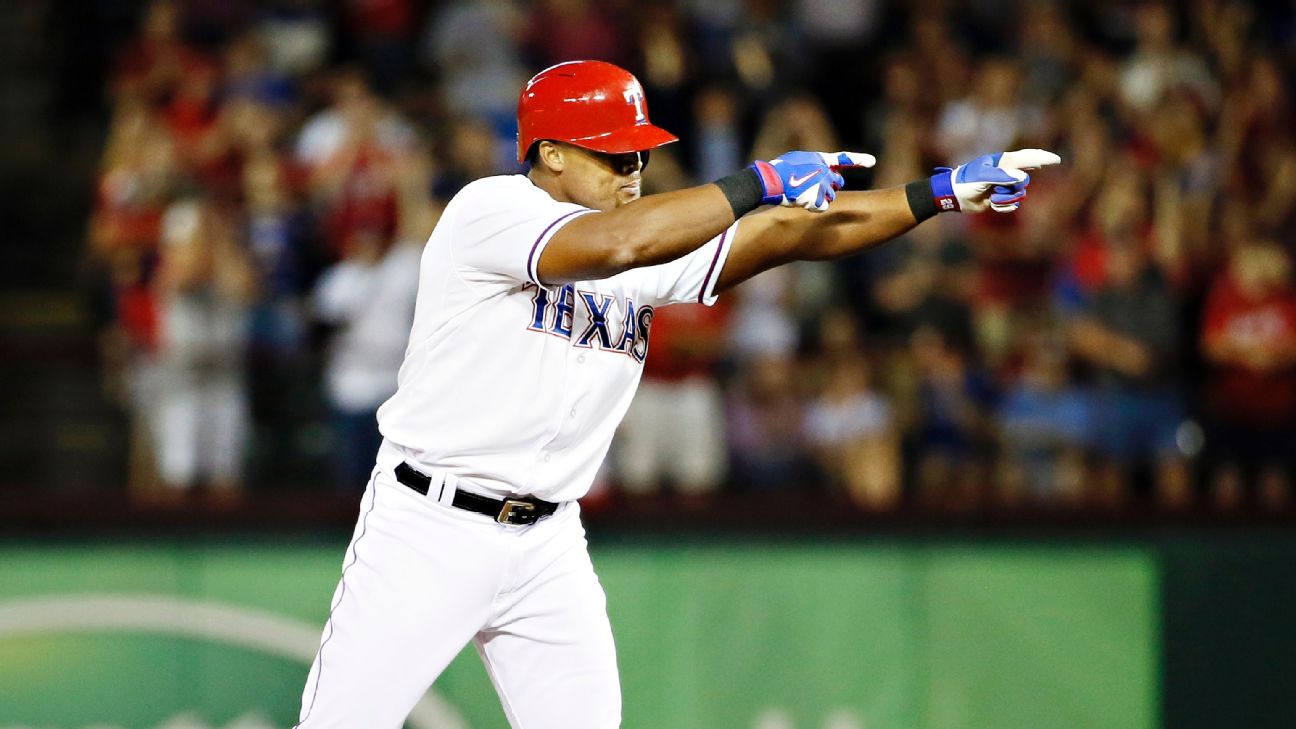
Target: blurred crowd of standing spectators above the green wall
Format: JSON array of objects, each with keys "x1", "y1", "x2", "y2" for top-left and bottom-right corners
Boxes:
[{"x1": 88, "y1": 0, "x2": 1296, "y2": 510}]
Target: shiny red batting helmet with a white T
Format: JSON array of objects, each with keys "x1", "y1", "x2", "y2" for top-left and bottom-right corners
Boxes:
[{"x1": 517, "y1": 61, "x2": 679, "y2": 162}]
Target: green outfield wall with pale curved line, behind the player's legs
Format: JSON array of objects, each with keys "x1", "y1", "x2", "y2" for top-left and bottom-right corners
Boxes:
[{"x1": 0, "y1": 540, "x2": 1160, "y2": 729}]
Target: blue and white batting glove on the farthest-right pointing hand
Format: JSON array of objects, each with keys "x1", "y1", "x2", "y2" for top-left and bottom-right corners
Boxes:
[{"x1": 932, "y1": 149, "x2": 1061, "y2": 213}]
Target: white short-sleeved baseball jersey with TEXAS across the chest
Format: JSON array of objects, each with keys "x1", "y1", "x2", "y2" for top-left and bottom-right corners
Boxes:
[{"x1": 378, "y1": 175, "x2": 737, "y2": 501}]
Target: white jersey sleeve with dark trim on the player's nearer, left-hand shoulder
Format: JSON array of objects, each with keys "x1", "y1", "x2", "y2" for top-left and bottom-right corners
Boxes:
[{"x1": 450, "y1": 175, "x2": 594, "y2": 285}]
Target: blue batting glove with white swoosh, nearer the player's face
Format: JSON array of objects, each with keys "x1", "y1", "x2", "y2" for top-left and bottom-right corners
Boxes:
[{"x1": 752, "y1": 152, "x2": 877, "y2": 213}]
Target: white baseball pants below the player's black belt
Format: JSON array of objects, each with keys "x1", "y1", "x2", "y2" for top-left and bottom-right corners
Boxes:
[{"x1": 298, "y1": 446, "x2": 621, "y2": 729}]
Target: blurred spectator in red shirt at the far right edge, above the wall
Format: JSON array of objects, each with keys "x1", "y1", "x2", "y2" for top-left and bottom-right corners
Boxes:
[{"x1": 1201, "y1": 243, "x2": 1296, "y2": 507}]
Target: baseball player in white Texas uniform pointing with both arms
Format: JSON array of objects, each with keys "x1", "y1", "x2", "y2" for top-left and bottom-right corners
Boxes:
[{"x1": 298, "y1": 61, "x2": 1059, "y2": 729}]
